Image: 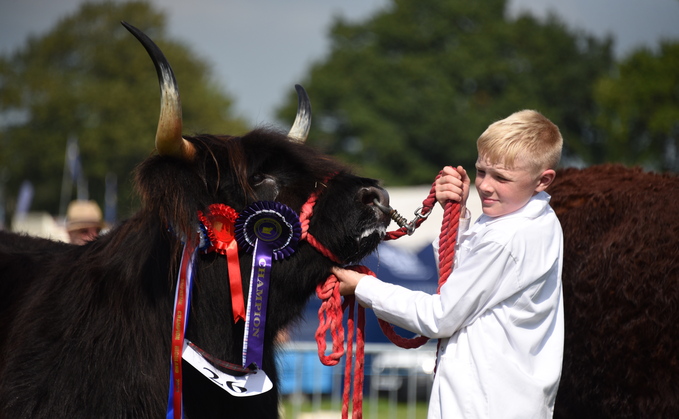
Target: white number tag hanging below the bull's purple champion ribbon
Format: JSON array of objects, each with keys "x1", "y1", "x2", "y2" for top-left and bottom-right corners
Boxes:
[{"x1": 182, "y1": 345, "x2": 273, "y2": 397}]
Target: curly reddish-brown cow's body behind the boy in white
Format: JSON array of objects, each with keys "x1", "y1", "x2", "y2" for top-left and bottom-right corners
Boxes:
[{"x1": 548, "y1": 165, "x2": 679, "y2": 419}]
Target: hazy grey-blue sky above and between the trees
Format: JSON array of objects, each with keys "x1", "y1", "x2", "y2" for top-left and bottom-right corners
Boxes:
[{"x1": 0, "y1": 0, "x2": 679, "y2": 128}]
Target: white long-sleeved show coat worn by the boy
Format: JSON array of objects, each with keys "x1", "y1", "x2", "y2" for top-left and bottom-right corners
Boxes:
[{"x1": 356, "y1": 192, "x2": 564, "y2": 419}]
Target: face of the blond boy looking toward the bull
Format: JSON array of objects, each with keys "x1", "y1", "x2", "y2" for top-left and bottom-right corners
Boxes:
[{"x1": 474, "y1": 156, "x2": 555, "y2": 217}]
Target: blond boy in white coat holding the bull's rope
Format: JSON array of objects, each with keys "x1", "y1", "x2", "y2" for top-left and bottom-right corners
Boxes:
[{"x1": 334, "y1": 110, "x2": 564, "y2": 419}]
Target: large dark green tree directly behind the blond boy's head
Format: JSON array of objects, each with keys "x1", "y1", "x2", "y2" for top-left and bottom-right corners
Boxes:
[{"x1": 279, "y1": 0, "x2": 612, "y2": 185}]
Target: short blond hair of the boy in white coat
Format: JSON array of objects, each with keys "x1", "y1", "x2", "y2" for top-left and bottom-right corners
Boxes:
[{"x1": 476, "y1": 110, "x2": 563, "y2": 173}]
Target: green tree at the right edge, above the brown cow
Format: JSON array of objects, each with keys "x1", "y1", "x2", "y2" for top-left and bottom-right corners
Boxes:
[{"x1": 588, "y1": 41, "x2": 679, "y2": 172}]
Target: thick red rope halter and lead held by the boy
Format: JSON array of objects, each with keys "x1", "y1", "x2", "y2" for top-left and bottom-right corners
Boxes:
[{"x1": 299, "y1": 173, "x2": 460, "y2": 419}]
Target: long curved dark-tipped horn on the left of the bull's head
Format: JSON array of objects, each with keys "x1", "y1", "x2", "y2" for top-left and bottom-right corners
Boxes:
[{"x1": 121, "y1": 22, "x2": 196, "y2": 160}]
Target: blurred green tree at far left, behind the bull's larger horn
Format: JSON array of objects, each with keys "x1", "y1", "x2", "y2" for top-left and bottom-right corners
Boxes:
[{"x1": 0, "y1": 1, "x2": 245, "y2": 223}]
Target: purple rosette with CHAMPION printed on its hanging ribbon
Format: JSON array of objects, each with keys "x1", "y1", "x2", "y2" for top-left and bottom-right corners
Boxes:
[{"x1": 235, "y1": 201, "x2": 301, "y2": 368}]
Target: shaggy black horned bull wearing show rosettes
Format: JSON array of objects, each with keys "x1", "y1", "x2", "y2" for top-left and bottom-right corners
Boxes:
[{"x1": 0, "y1": 25, "x2": 388, "y2": 419}]
